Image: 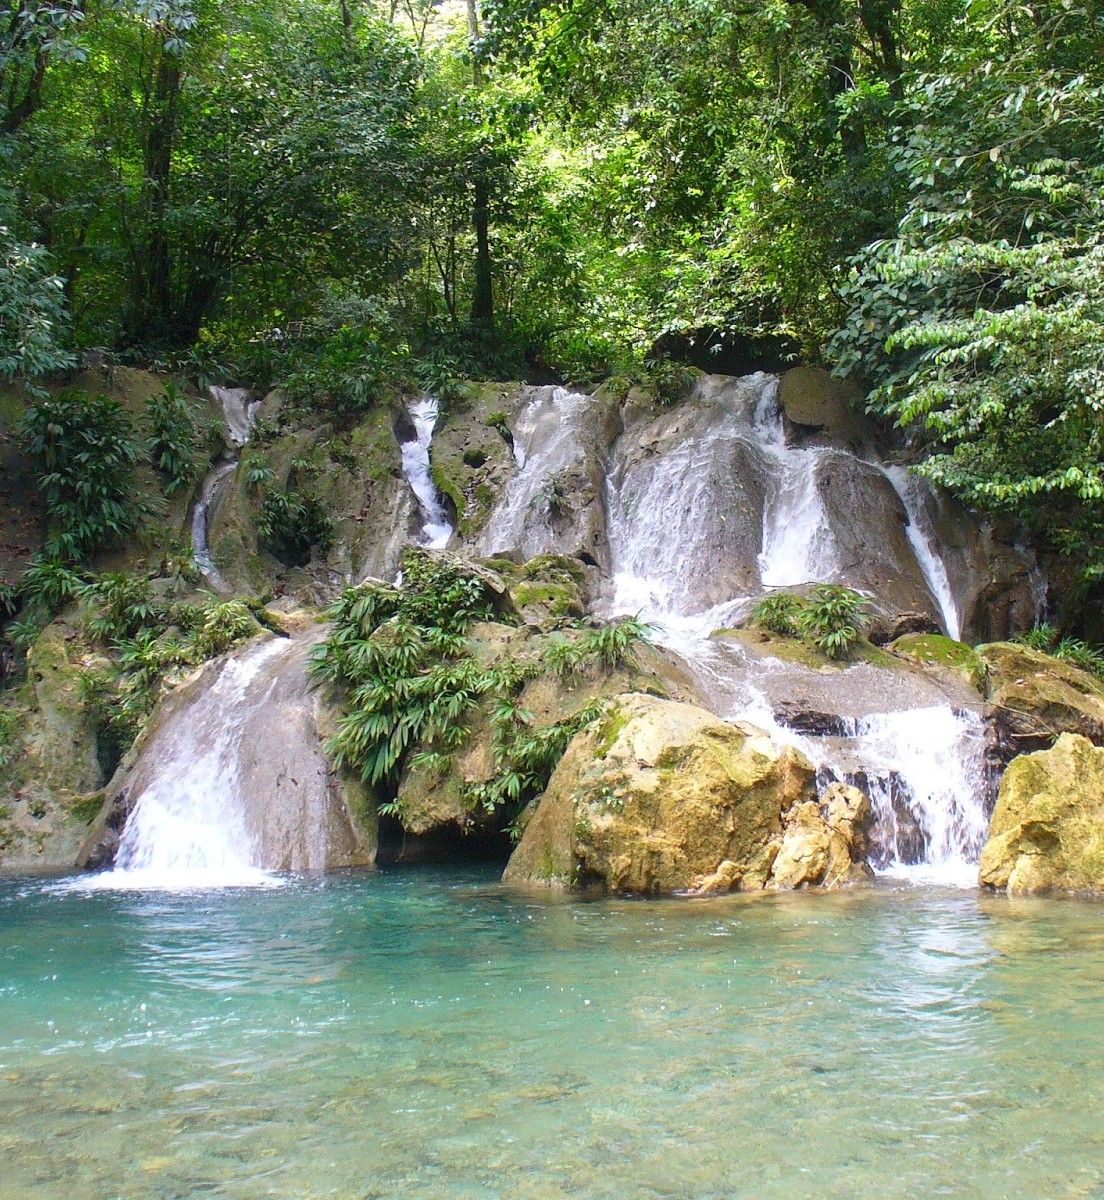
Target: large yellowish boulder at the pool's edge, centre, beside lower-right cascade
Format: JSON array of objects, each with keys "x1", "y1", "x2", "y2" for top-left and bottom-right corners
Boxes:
[{"x1": 504, "y1": 695, "x2": 863, "y2": 895}]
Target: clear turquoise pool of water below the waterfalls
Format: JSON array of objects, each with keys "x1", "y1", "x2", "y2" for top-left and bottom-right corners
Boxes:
[{"x1": 0, "y1": 870, "x2": 1104, "y2": 1200}]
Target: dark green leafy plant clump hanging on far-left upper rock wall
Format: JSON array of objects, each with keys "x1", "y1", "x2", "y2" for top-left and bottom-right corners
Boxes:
[{"x1": 22, "y1": 388, "x2": 150, "y2": 559}]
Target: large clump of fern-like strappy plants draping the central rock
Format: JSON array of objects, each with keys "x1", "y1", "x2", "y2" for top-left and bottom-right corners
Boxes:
[{"x1": 311, "y1": 550, "x2": 647, "y2": 814}]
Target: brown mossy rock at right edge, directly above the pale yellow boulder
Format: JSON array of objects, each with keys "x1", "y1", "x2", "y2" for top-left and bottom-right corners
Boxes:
[{"x1": 977, "y1": 642, "x2": 1104, "y2": 763}]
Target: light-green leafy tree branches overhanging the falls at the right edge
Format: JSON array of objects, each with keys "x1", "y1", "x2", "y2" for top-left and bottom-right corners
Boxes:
[{"x1": 830, "y1": 5, "x2": 1104, "y2": 590}]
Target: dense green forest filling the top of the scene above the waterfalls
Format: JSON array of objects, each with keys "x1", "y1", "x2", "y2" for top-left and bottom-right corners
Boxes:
[{"x1": 0, "y1": 0, "x2": 1104, "y2": 588}]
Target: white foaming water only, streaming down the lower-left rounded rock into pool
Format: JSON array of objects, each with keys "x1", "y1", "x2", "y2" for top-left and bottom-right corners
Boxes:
[{"x1": 74, "y1": 638, "x2": 293, "y2": 890}]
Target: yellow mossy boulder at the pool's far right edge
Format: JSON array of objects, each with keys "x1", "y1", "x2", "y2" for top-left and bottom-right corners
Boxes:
[{"x1": 978, "y1": 733, "x2": 1104, "y2": 892}]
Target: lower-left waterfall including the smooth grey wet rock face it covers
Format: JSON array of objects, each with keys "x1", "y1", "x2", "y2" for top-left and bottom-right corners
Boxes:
[{"x1": 74, "y1": 629, "x2": 371, "y2": 889}]
